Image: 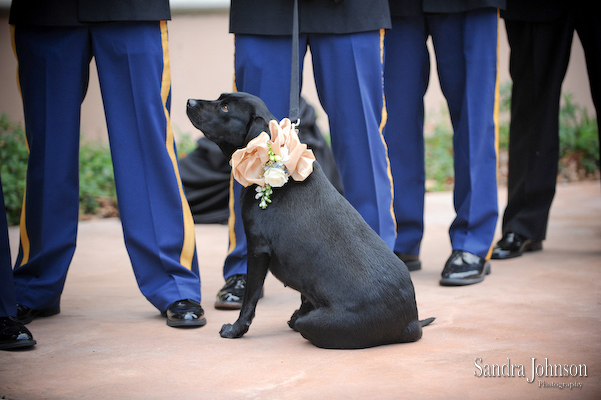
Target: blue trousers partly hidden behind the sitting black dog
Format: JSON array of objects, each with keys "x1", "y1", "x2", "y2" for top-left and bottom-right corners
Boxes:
[{"x1": 224, "y1": 31, "x2": 395, "y2": 279}]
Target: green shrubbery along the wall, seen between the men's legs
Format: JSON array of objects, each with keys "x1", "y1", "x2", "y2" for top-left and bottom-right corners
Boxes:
[{"x1": 0, "y1": 83, "x2": 599, "y2": 225}]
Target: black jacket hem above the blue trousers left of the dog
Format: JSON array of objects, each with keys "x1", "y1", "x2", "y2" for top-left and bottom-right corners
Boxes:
[{"x1": 9, "y1": 0, "x2": 171, "y2": 26}]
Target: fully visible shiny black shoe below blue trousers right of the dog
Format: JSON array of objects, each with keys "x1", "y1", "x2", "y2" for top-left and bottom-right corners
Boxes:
[{"x1": 440, "y1": 250, "x2": 490, "y2": 286}]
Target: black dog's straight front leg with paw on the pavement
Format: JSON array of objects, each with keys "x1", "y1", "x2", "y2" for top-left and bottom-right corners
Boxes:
[{"x1": 219, "y1": 253, "x2": 271, "y2": 339}]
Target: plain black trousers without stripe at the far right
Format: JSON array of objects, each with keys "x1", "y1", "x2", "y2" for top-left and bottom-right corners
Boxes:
[{"x1": 503, "y1": 10, "x2": 601, "y2": 241}]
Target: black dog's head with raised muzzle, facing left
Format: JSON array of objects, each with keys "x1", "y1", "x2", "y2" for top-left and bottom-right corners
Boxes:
[{"x1": 187, "y1": 92, "x2": 275, "y2": 159}]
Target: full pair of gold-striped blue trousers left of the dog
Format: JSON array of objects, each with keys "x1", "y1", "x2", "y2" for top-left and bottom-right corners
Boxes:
[{"x1": 14, "y1": 21, "x2": 200, "y2": 311}]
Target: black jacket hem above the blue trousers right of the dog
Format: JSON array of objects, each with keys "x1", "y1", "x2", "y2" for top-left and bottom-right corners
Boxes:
[{"x1": 389, "y1": 0, "x2": 505, "y2": 17}]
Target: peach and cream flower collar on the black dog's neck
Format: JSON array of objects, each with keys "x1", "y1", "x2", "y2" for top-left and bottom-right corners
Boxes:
[{"x1": 230, "y1": 118, "x2": 315, "y2": 209}]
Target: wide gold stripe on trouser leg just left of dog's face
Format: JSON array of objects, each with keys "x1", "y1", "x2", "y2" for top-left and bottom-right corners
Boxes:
[{"x1": 161, "y1": 21, "x2": 195, "y2": 269}]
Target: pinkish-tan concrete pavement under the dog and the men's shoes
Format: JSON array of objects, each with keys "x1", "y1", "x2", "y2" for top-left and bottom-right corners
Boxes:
[{"x1": 0, "y1": 181, "x2": 601, "y2": 400}]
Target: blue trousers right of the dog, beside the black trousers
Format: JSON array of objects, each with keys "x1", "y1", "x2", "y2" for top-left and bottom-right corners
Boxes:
[{"x1": 384, "y1": 8, "x2": 498, "y2": 258}]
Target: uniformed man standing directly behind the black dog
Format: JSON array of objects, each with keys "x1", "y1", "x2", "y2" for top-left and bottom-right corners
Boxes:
[{"x1": 215, "y1": 0, "x2": 395, "y2": 309}]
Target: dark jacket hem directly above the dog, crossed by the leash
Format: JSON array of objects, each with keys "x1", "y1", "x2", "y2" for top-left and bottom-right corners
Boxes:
[{"x1": 230, "y1": 0, "x2": 390, "y2": 35}]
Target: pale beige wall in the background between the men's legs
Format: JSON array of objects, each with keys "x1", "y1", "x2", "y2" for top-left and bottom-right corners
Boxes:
[{"x1": 0, "y1": 7, "x2": 594, "y2": 144}]
